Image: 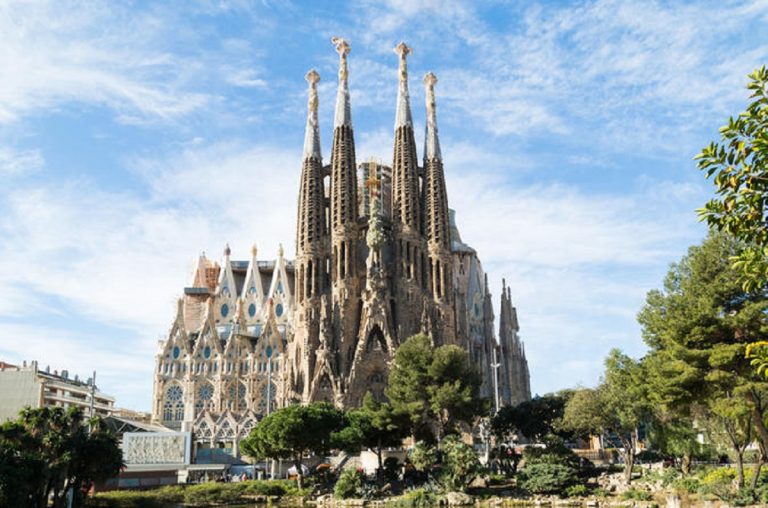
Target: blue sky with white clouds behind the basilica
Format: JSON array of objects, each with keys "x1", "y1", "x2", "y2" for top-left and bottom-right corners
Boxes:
[{"x1": 0, "y1": 0, "x2": 768, "y2": 410}]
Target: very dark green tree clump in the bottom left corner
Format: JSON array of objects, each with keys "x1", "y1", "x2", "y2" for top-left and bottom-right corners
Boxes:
[{"x1": 0, "y1": 407, "x2": 123, "y2": 508}]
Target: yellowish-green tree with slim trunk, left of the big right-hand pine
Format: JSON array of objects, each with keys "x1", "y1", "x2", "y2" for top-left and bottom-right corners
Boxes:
[{"x1": 563, "y1": 349, "x2": 649, "y2": 484}]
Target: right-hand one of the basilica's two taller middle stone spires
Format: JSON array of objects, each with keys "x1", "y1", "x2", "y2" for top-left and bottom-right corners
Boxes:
[{"x1": 392, "y1": 42, "x2": 421, "y2": 233}]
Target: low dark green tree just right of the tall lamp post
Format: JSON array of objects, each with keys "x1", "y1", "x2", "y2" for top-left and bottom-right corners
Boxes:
[{"x1": 491, "y1": 390, "x2": 573, "y2": 443}]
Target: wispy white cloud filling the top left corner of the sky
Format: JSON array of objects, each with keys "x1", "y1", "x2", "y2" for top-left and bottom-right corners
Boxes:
[{"x1": 0, "y1": 0, "x2": 278, "y2": 124}]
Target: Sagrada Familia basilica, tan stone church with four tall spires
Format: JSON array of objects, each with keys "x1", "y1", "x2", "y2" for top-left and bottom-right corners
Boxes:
[{"x1": 153, "y1": 39, "x2": 530, "y2": 456}]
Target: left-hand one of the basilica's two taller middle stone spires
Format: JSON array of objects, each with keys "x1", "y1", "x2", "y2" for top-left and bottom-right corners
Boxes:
[{"x1": 330, "y1": 37, "x2": 357, "y2": 282}]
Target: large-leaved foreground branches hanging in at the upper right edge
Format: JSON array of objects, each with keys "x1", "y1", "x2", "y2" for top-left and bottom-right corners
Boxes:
[{"x1": 696, "y1": 66, "x2": 768, "y2": 291}]
